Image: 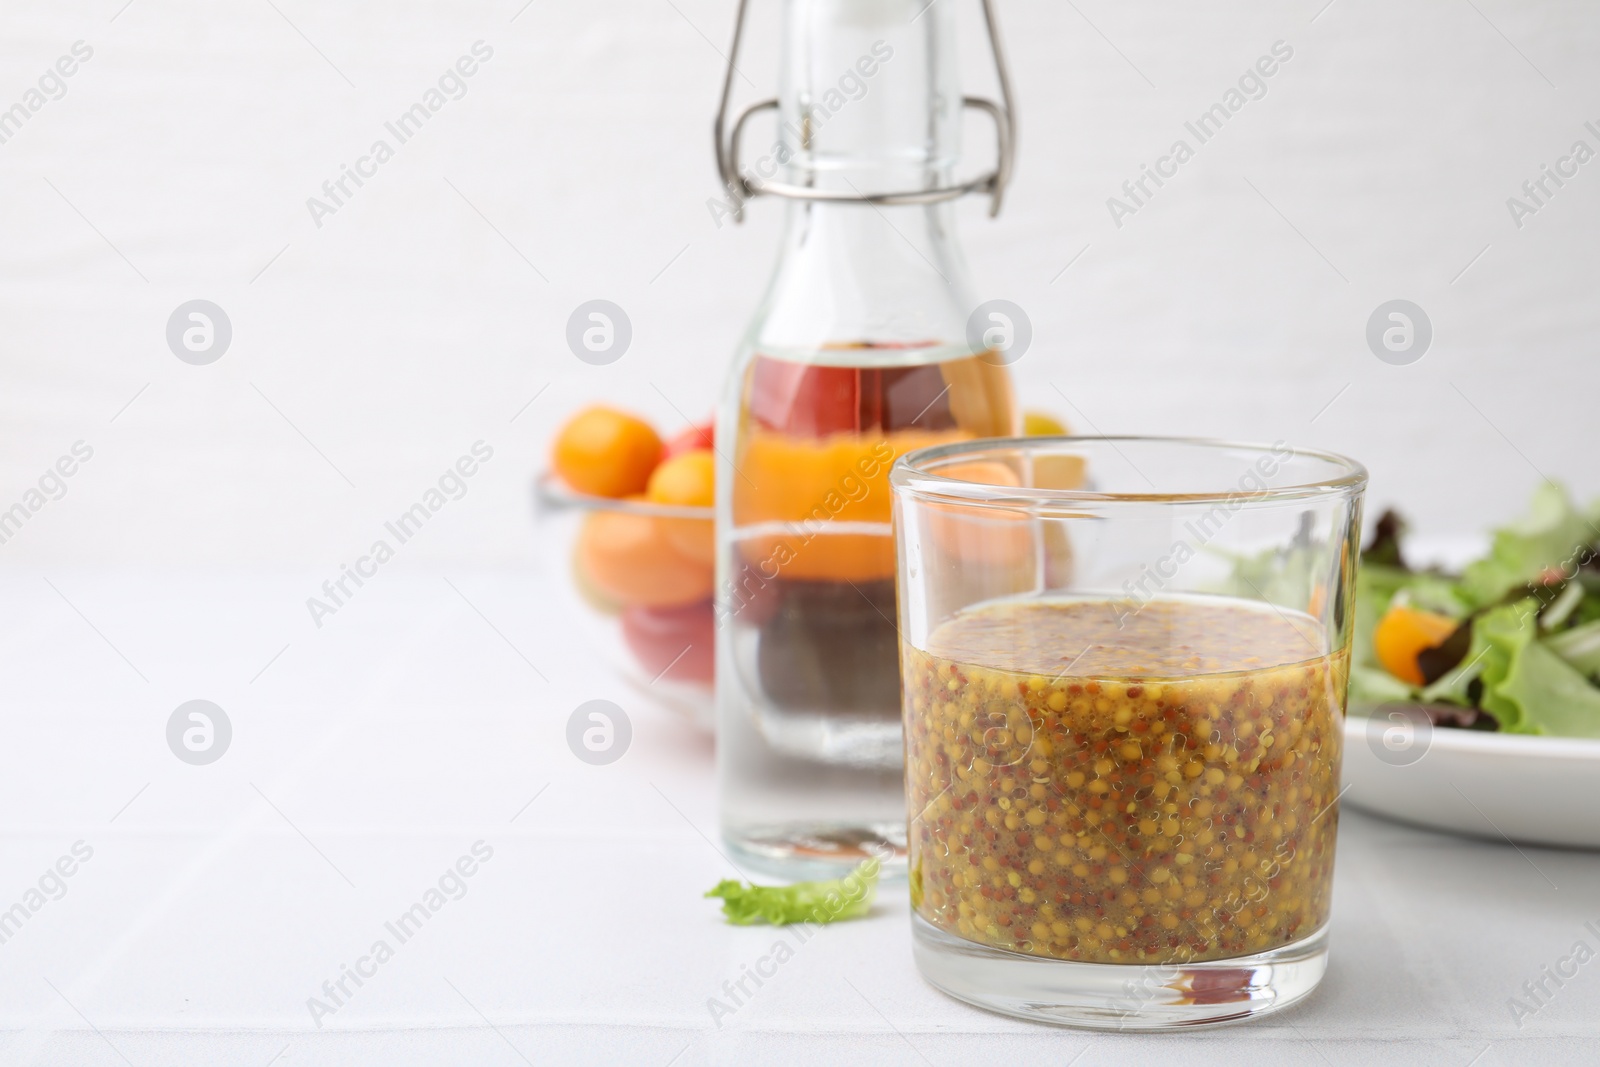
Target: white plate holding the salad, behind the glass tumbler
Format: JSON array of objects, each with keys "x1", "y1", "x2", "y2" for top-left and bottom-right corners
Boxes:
[{"x1": 1341, "y1": 715, "x2": 1600, "y2": 848}]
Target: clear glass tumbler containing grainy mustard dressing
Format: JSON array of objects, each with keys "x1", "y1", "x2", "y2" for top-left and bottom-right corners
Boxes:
[{"x1": 890, "y1": 437, "x2": 1366, "y2": 1030}]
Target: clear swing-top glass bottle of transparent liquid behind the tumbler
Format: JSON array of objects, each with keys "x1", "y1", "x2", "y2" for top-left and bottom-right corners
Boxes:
[{"x1": 717, "y1": 0, "x2": 1019, "y2": 878}]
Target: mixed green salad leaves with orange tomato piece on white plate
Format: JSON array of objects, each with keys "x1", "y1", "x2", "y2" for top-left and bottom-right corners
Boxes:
[{"x1": 1350, "y1": 483, "x2": 1600, "y2": 737}]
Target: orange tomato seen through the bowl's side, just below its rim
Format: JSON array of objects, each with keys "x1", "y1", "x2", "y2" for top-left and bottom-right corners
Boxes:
[{"x1": 578, "y1": 512, "x2": 714, "y2": 608}]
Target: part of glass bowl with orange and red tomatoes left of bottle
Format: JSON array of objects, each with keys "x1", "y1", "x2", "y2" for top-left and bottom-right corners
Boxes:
[{"x1": 534, "y1": 406, "x2": 717, "y2": 729}]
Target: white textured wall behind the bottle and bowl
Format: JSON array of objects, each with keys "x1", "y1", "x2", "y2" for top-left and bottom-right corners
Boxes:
[{"x1": 0, "y1": 0, "x2": 1600, "y2": 566}]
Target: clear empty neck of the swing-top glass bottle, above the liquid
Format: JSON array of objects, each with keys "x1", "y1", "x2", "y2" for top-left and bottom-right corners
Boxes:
[{"x1": 752, "y1": 0, "x2": 974, "y2": 365}]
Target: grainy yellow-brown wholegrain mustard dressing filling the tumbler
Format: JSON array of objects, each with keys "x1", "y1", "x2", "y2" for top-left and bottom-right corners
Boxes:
[{"x1": 901, "y1": 598, "x2": 1349, "y2": 963}]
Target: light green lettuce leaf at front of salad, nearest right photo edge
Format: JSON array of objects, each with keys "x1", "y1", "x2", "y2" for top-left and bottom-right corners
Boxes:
[{"x1": 1467, "y1": 597, "x2": 1600, "y2": 737}]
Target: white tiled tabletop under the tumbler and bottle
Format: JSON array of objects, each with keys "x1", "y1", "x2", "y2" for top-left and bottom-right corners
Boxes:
[{"x1": 0, "y1": 568, "x2": 1600, "y2": 1067}]
